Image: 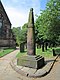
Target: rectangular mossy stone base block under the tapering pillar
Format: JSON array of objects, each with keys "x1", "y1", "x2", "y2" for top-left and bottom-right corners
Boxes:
[{"x1": 17, "y1": 55, "x2": 44, "y2": 69}]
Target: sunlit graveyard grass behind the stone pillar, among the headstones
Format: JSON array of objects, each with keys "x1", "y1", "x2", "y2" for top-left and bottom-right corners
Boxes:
[{"x1": 16, "y1": 47, "x2": 60, "y2": 58}]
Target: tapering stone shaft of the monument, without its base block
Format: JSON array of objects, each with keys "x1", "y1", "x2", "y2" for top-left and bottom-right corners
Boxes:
[{"x1": 27, "y1": 8, "x2": 35, "y2": 55}]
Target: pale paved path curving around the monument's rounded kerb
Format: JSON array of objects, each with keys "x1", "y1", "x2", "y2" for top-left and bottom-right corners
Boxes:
[{"x1": 0, "y1": 47, "x2": 60, "y2": 80}]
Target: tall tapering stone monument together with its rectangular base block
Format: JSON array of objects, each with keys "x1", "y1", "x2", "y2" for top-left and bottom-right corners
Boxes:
[{"x1": 17, "y1": 8, "x2": 44, "y2": 69}]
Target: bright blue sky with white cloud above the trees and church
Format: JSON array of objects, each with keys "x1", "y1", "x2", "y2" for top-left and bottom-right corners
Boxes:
[{"x1": 1, "y1": 0, "x2": 48, "y2": 27}]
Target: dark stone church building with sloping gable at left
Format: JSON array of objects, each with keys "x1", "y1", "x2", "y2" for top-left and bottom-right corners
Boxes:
[{"x1": 0, "y1": 0, "x2": 16, "y2": 48}]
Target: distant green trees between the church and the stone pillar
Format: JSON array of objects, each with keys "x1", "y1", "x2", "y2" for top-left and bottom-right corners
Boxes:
[{"x1": 12, "y1": 23, "x2": 27, "y2": 45}]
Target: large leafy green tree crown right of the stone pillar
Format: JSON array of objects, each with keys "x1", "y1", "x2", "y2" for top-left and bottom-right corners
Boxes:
[{"x1": 35, "y1": 0, "x2": 60, "y2": 42}]
